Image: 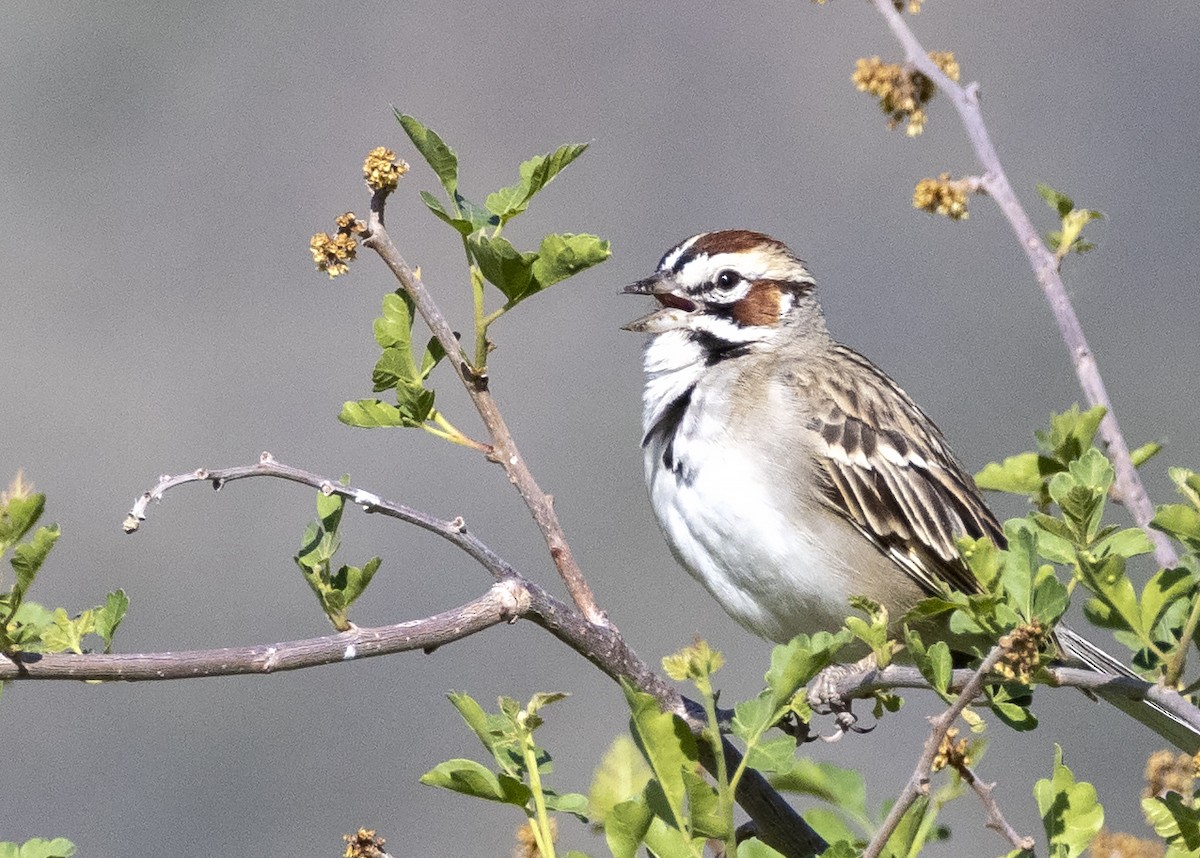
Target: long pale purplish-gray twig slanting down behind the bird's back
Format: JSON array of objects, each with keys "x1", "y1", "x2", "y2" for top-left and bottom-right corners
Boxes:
[{"x1": 871, "y1": 0, "x2": 1178, "y2": 566}]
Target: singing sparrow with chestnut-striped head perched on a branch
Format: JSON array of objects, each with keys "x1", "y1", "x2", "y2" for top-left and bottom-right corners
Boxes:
[{"x1": 623, "y1": 229, "x2": 1200, "y2": 754}]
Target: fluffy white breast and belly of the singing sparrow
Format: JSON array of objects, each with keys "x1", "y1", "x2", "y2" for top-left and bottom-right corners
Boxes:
[{"x1": 643, "y1": 335, "x2": 853, "y2": 641}]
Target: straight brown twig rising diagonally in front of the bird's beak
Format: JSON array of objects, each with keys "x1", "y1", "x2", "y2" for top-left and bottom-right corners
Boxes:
[{"x1": 352, "y1": 191, "x2": 600, "y2": 625}]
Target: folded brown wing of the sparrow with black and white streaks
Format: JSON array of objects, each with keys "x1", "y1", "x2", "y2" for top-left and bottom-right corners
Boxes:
[{"x1": 809, "y1": 346, "x2": 1004, "y2": 593}]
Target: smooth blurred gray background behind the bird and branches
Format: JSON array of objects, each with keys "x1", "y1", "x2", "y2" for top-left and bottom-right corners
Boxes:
[{"x1": 0, "y1": 0, "x2": 1200, "y2": 858}]
